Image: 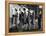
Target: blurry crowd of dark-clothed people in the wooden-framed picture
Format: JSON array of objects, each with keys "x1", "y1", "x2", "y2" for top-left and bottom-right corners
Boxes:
[{"x1": 10, "y1": 4, "x2": 41, "y2": 32}]
